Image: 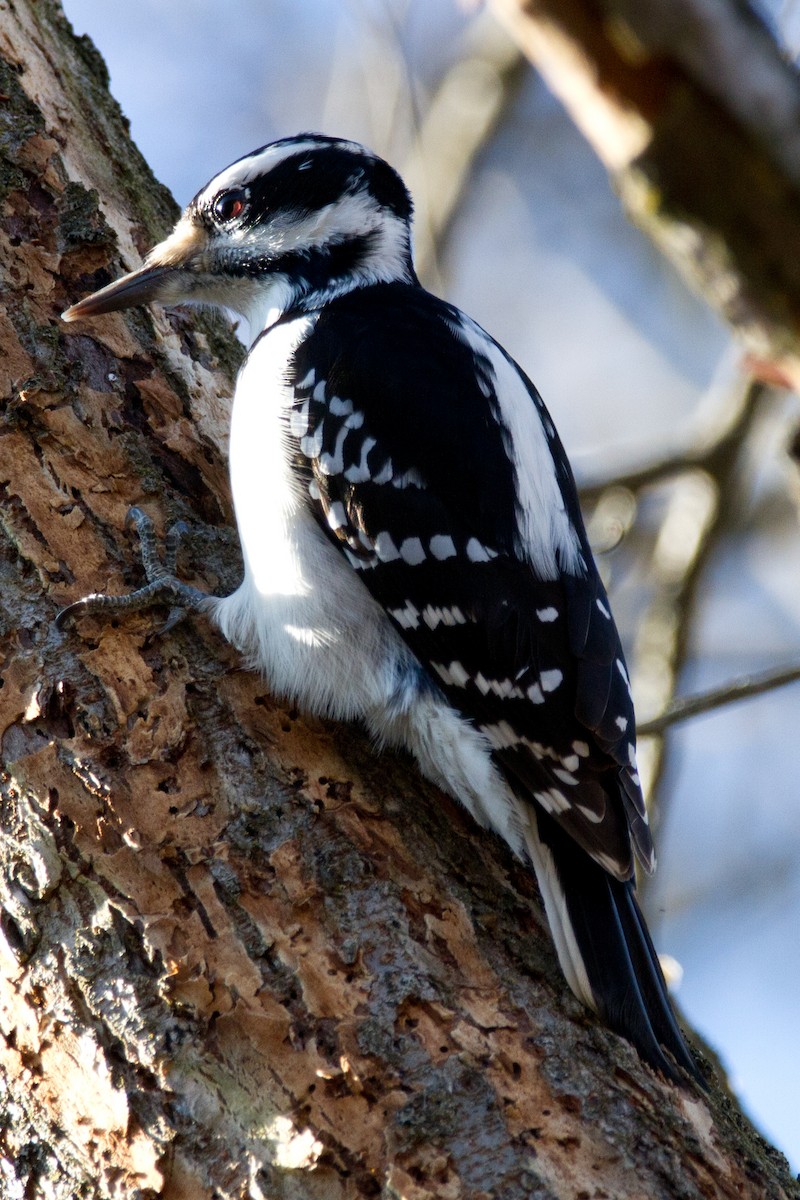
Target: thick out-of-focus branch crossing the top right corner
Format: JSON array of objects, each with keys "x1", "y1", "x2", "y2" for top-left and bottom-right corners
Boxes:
[{"x1": 492, "y1": 0, "x2": 800, "y2": 389}]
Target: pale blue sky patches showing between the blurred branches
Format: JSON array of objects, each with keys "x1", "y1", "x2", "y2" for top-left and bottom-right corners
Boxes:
[{"x1": 64, "y1": 0, "x2": 800, "y2": 1171}]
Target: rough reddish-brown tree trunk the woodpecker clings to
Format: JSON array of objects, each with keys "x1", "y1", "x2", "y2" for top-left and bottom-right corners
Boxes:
[{"x1": 0, "y1": 0, "x2": 794, "y2": 1200}]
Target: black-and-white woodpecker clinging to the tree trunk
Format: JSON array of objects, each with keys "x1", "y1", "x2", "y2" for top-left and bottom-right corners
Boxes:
[{"x1": 64, "y1": 133, "x2": 699, "y2": 1081}]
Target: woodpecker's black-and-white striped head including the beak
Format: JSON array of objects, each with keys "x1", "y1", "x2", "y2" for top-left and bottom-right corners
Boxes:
[{"x1": 64, "y1": 133, "x2": 414, "y2": 336}]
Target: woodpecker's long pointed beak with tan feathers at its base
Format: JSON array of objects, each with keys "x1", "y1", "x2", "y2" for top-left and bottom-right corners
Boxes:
[{"x1": 61, "y1": 217, "x2": 207, "y2": 320}]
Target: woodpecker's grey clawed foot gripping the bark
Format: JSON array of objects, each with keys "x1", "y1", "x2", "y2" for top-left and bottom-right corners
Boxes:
[{"x1": 55, "y1": 508, "x2": 210, "y2": 634}]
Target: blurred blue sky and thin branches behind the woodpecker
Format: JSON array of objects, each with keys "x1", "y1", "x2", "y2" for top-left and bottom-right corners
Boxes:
[{"x1": 64, "y1": 0, "x2": 800, "y2": 1171}]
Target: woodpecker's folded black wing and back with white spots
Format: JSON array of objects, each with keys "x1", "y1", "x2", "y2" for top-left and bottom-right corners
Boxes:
[{"x1": 289, "y1": 286, "x2": 652, "y2": 878}]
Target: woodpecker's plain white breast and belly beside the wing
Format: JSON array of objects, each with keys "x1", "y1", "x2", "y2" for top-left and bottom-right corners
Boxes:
[{"x1": 213, "y1": 316, "x2": 410, "y2": 718}]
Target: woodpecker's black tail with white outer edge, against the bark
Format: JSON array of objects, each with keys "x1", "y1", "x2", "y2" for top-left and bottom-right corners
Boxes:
[{"x1": 528, "y1": 810, "x2": 705, "y2": 1086}]
